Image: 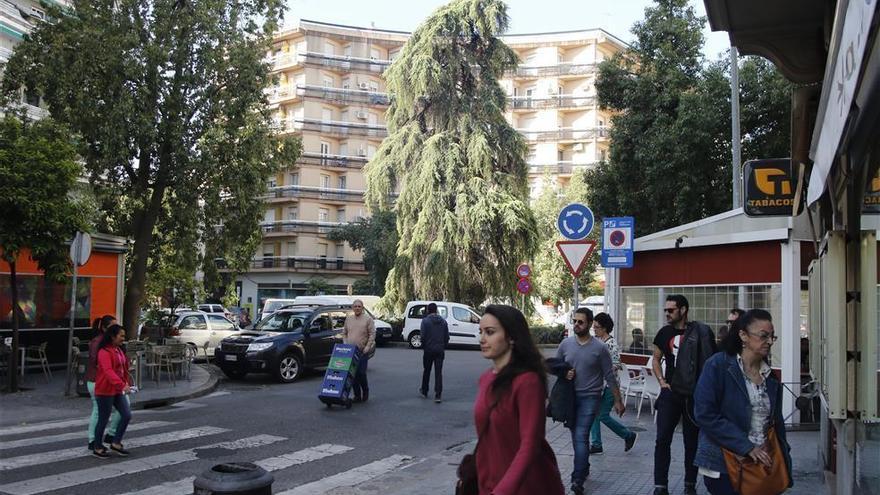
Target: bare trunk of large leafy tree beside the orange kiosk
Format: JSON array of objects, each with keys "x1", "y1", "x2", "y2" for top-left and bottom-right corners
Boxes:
[{"x1": 122, "y1": 184, "x2": 165, "y2": 336}]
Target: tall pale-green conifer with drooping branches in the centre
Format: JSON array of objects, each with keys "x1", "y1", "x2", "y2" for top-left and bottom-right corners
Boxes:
[{"x1": 366, "y1": 0, "x2": 537, "y2": 309}]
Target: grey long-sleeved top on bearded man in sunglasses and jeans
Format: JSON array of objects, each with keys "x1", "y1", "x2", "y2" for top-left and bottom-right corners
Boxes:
[{"x1": 556, "y1": 335, "x2": 617, "y2": 395}]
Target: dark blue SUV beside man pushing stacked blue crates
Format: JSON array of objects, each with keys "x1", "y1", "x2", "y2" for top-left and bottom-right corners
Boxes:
[{"x1": 214, "y1": 304, "x2": 350, "y2": 383}]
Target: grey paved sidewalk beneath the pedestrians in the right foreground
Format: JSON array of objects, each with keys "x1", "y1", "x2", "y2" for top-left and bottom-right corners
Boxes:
[{"x1": 328, "y1": 407, "x2": 829, "y2": 495}]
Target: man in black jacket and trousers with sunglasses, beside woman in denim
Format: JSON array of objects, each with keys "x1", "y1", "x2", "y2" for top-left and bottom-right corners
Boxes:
[{"x1": 651, "y1": 294, "x2": 716, "y2": 495}]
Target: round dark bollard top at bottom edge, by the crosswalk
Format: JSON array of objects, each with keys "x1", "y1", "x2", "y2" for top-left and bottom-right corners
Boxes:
[{"x1": 193, "y1": 462, "x2": 275, "y2": 495}]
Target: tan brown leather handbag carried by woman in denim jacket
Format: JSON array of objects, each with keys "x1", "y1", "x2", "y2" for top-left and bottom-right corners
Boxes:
[{"x1": 721, "y1": 426, "x2": 791, "y2": 495}]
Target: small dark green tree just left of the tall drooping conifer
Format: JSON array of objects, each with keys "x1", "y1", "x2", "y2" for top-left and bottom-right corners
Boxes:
[{"x1": 327, "y1": 210, "x2": 398, "y2": 296}]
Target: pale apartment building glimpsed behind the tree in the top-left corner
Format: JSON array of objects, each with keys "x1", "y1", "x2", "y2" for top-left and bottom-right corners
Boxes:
[{"x1": 0, "y1": 0, "x2": 64, "y2": 119}]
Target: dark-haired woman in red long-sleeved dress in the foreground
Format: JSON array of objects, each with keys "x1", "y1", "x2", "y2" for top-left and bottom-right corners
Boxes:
[{"x1": 474, "y1": 305, "x2": 565, "y2": 495}]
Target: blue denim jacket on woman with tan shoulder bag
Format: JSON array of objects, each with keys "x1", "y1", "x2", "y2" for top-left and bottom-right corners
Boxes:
[{"x1": 694, "y1": 352, "x2": 792, "y2": 479}]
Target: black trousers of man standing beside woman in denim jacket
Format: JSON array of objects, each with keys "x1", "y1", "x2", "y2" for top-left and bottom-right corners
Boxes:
[{"x1": 654, "y1": 388, "x2": 700, "y2": 486}]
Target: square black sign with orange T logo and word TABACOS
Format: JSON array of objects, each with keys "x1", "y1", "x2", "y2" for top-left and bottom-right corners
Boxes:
[{"x1": 743, "y1": 158, "x2": 801, "y2": 217}]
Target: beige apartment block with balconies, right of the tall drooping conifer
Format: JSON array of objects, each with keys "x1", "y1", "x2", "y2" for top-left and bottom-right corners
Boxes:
[{"x1": 501, "y1": 29, "x2": 626, "y2": 198}]
